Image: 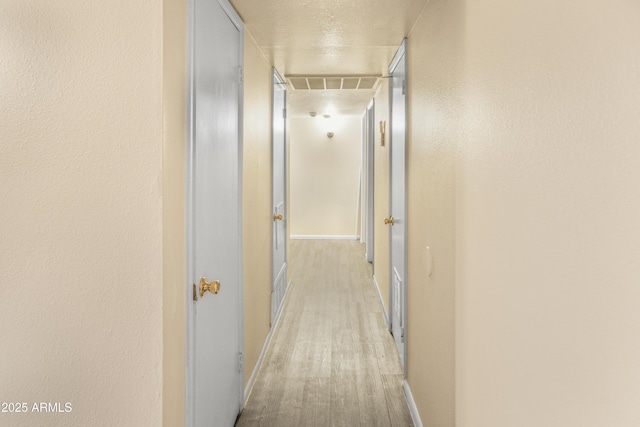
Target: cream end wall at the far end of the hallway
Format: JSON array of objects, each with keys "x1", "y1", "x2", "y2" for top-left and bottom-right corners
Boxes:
[{"x1": 289, "y1": 116, "x2": 362, "y2": 236}]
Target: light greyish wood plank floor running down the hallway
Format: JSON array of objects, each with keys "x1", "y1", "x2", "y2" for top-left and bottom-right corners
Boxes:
[{"x1": 236, "y1": 240, "x2": 413, "y2": 427}]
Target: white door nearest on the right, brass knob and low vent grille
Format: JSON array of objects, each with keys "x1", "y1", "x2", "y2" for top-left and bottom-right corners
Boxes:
[{"x1": 387, "y1": 40, "x2": 407, "y2": 373}]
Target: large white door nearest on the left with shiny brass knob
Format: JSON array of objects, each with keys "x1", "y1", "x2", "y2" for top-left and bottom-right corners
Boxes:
[{"x1": 186, "y1": 0, "x2": 243, "y2": 427}]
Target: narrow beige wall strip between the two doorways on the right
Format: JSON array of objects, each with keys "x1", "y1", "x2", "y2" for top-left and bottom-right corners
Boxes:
[{"x1": 373, "y1": 79, "x2": 391, "y2": 315}]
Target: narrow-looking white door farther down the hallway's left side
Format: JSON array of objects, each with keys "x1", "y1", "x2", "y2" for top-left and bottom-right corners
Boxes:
[{"x1": 271, "y1": 69, "x2": 287, "y2": 324}]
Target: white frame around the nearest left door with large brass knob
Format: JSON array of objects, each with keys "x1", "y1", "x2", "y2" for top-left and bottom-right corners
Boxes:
[{"x1": 184, "y1": 0, "x2": 244, "y2": 427}]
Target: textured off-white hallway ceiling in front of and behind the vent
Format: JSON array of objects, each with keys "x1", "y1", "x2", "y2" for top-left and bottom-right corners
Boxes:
[{"x1": 230, "y1": 0, "x2": 427, "y2": 116}]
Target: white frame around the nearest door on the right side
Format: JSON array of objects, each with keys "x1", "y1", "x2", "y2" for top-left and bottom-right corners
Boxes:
[{"x1": 389, "y1": 38, "x2": 409, "y2": 377}]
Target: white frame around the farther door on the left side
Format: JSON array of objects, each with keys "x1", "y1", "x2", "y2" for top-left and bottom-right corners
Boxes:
[{"x1": 270, "y1": 67, "x2": 289, "y2": 327}]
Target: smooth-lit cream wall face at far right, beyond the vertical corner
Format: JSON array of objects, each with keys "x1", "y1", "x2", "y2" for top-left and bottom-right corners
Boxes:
[{"x1": 456, "y1": 0, "x2": 640, "y2": 427}]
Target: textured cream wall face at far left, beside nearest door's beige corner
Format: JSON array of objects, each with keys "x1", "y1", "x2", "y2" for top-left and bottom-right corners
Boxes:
[{"x1": 0, "y1": 0, "x2": 163, "y2": 427}]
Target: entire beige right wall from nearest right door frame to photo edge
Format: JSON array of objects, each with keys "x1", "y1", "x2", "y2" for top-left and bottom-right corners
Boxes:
[{"x1": 407, "y1": 0, "x2": 640, "y2": 427}]
